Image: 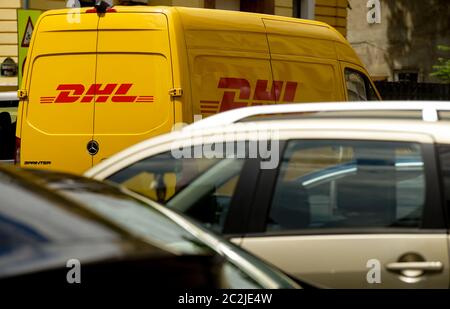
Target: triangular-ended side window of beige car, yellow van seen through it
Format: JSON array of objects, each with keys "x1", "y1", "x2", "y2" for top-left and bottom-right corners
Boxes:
[{"x1": 107, "y1": 147, "x2": 244, "y2": 231}]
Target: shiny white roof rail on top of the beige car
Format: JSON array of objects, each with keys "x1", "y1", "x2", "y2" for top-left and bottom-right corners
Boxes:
[{"x1": 184, "y1": 101, "x2": 450, "y2": 130}]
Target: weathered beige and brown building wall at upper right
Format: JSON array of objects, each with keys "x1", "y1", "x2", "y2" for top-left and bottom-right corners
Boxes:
[{"x1": 347, "y1": 0, "x2": 450, "y2": 82}]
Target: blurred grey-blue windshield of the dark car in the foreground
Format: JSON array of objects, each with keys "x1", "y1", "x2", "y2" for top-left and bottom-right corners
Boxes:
[{"x1": 0, "y1": 170, "x2": 132, "y2": 277}]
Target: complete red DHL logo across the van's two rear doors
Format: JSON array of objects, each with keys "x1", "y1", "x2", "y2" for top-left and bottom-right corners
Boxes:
[{"x1": 40, "y1": 84, "x2": 154, "y2": 104}]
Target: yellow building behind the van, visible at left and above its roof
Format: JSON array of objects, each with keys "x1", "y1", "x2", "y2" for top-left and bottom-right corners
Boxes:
[{"x1": 0, "y1": 0, "x2": 348, "y2": 91}]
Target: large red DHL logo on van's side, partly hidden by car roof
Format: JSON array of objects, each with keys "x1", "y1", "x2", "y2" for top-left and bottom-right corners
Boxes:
[{"x1": 200, "y1": 77, "x2": 298, "y2": 114}]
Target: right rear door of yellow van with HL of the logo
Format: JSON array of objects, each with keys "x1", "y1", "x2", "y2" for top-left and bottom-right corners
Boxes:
[{"x1": 92, "y1": 12, "x2": 174, "y2": 164}]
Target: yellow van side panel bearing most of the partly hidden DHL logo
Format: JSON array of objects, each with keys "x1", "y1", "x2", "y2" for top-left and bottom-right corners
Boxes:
[{"x1": 189, "y1": 50, "x2": 275, "y2": 117}]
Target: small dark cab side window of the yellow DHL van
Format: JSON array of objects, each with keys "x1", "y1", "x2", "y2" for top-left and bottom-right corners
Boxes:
[{"x1": 344, "y1": 68, "x2": 378, "y2": 101}]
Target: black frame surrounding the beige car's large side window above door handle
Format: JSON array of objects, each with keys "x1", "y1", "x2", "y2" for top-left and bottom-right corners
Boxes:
[{"x1": 246, "y1": 137, "x2": 448, "y2": 237}]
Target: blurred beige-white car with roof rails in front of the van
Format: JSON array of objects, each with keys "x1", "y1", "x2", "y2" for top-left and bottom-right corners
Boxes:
[{"x1": 85, "y1": 102, "x2": 450, "y2": 288}]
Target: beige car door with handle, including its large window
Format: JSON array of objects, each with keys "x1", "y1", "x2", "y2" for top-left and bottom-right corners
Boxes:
[{"x1": 241, "y1": 132, "x2": 449, "y2": 288}]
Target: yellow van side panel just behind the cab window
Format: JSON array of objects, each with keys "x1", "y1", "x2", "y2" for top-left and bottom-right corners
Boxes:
[{"x1": 264, "y1": 19, "x2": 344, "y2": 103}]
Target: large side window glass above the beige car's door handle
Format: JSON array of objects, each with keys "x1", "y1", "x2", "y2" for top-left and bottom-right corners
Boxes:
[{"x1": 266, "y1": 140, "x2": 425, "y2": 232}]
